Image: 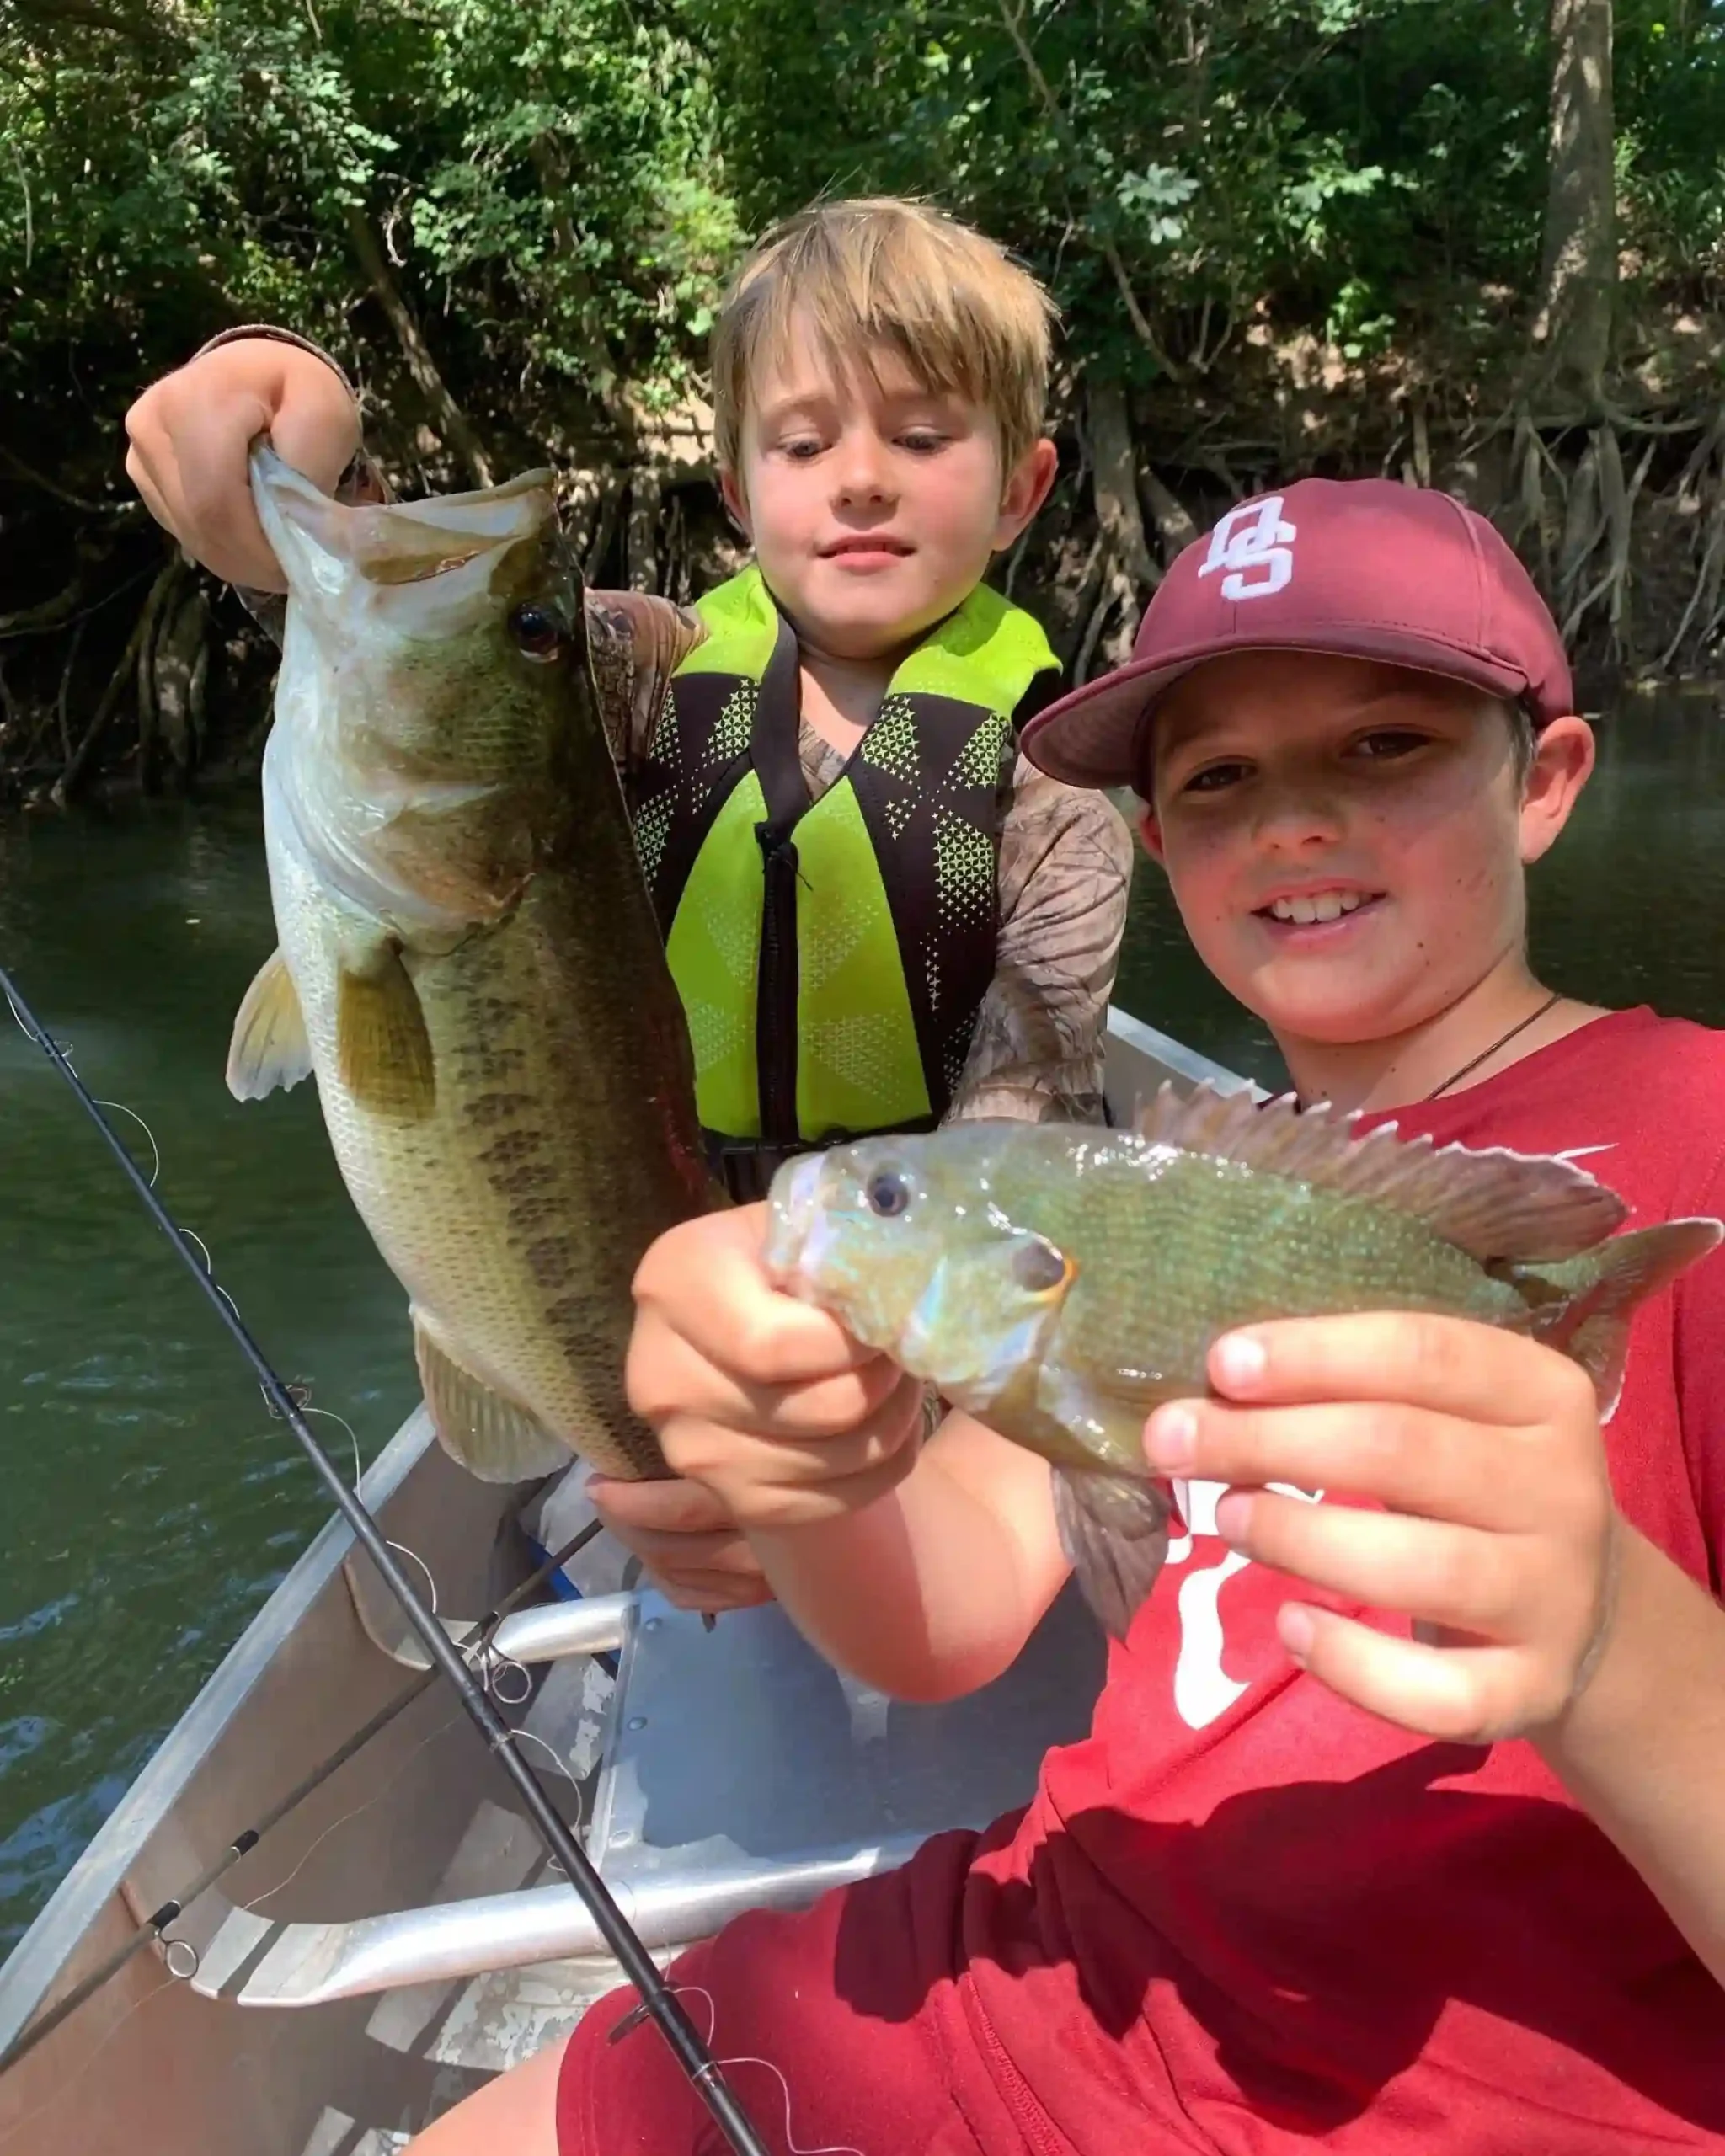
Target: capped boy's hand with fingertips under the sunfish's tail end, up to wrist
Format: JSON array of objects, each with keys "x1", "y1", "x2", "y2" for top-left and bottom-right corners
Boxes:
[{"x1": 1145, "y1": 1310, "x2": 1634, "y2": 1744}]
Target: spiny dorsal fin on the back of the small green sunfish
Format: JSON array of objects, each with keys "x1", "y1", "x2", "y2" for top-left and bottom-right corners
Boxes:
[{"x1": 1139, "y1": 1085, "x2": 1628, "y2": 1266}]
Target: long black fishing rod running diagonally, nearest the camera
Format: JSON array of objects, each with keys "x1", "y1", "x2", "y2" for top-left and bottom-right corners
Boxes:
[{"x1": 0, "y1": 966, "x2": 767, "y2": 2156}]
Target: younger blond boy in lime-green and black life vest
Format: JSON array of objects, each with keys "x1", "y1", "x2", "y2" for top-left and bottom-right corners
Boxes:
[{"x1": 127, "y1": 200, "x2": 1132, "y2": 1606}]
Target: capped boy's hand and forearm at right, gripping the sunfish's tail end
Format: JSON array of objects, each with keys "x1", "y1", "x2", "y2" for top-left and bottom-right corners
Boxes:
[{"x1": 1147, "y1": 1294, "x2": 1725, "y2": 1983}]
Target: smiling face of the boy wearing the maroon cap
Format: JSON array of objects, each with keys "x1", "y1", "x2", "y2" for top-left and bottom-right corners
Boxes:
[{"x1": 1140, "y1": 633, "x2": 1585, "y2": 1078}]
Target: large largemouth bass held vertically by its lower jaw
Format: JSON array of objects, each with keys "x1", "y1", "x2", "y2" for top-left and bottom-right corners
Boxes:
[{"x1": 228, "y1": 451, "x2": 712, "y2": 1481}]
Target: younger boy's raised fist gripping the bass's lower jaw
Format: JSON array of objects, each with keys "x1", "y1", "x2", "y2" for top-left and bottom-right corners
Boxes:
[{"x1": 125, "y1": 336, "x2": 360, "y2": 590}]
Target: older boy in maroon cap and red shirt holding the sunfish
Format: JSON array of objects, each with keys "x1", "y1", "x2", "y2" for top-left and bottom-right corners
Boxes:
[{"x1": 401, "y1": 481, "x2": 1725, "y2": 2156}]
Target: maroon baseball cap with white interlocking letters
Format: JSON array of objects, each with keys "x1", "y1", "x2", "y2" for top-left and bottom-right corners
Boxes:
[{"x1": 1024, "y1": 478, "x2": 1574, "y2": 787}]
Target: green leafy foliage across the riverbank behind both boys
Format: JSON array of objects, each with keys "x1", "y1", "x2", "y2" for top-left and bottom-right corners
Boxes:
[{"x1": 0, "y1": 0, "x2": 1725, "y2": 480}]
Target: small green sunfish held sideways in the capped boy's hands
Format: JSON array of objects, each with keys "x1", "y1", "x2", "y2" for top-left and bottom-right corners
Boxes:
[{"x1": 767, "y1": 1086, "x2": 1725, "y2": 1636}]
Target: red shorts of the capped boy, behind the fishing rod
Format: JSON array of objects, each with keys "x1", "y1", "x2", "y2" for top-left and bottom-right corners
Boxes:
[{"x1": 556, "y1": 1822, "x2": 1052, "y2": 2156}]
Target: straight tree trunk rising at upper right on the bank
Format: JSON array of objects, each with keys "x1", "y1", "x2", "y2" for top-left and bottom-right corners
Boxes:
[{"x1": 1533, "y1": 0, "x2": 1617, "y2": 414}]
